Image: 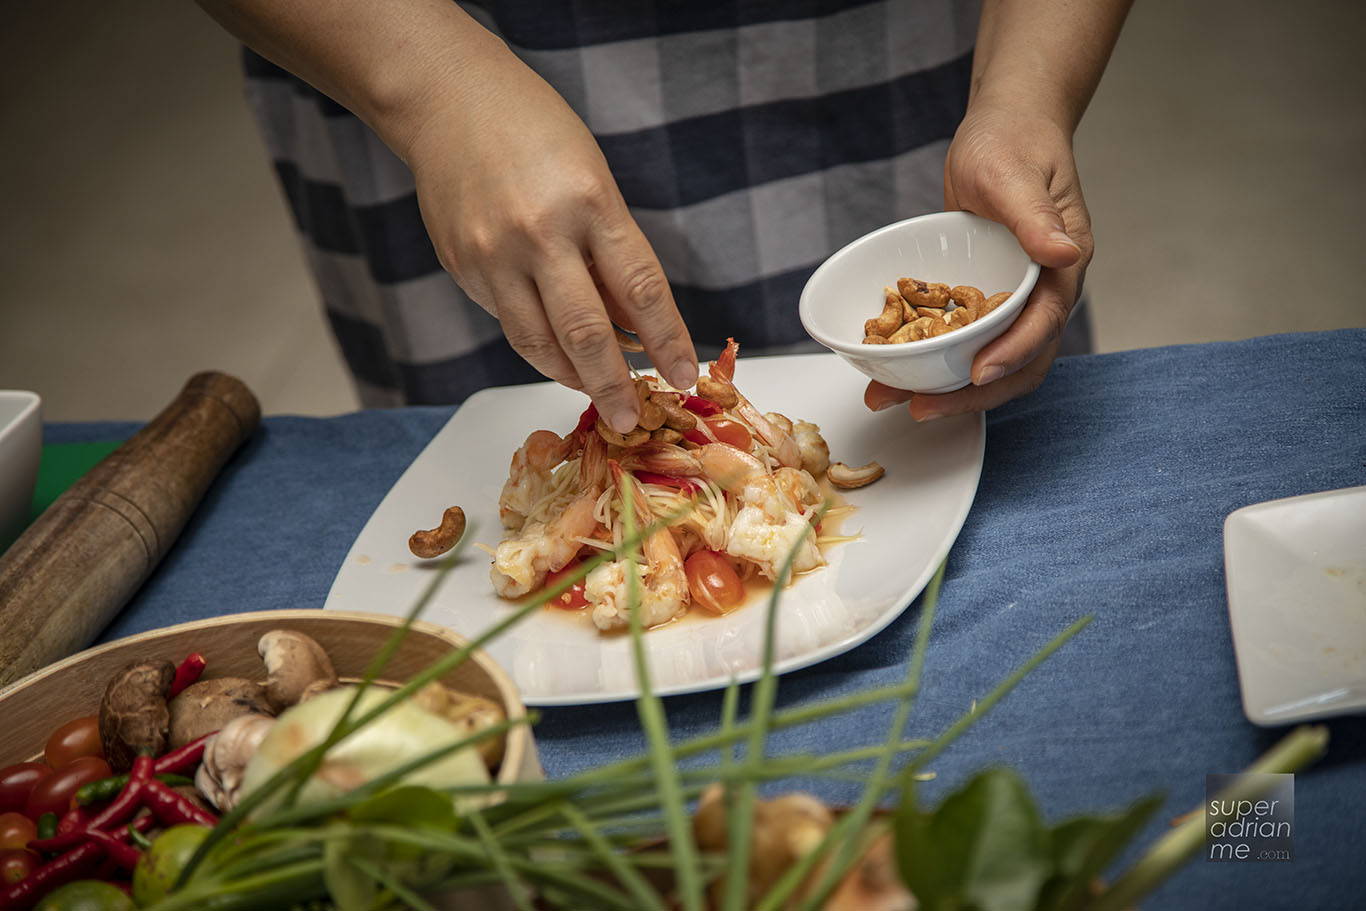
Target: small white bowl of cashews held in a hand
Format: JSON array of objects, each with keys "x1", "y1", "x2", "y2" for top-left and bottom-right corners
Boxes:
[{"x1": 799, "y1": 212, "x2": 1038, "y2": 392}]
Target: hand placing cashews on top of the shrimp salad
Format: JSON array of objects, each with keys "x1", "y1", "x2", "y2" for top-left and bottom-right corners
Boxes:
[{"x1": 404, "y1": 40, "x2": 698, "y2": 432}]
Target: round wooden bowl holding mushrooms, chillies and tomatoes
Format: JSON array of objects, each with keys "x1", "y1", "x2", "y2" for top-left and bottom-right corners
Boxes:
[{"x1": 0, "y1": 611, "x2": 544, "y2": 783}]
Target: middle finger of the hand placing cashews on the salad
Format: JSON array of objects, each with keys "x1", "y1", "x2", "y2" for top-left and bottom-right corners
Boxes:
[{"x1": 537, "y1": 250, "x2": 641, "y2": 433}]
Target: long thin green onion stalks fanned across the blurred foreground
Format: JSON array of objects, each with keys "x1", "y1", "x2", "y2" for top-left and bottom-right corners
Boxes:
[{"x1": 144, "y1": 505, "x2": 1325, "y2": 911}]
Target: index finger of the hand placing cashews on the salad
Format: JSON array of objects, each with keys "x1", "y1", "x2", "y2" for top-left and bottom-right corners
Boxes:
[{"x1": 593, "y1": 223, "x2": 698, "y2": 389}]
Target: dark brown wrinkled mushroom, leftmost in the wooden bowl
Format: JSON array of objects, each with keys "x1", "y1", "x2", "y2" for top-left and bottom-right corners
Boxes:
[{"x1": 100, "y1": 661, "x2": 175, "y2": 772}]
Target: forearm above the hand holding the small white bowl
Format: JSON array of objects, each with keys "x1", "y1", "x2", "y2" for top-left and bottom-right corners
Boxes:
[{"x1": 970, "y1": 0, "x2": 1132, "y2": 134}]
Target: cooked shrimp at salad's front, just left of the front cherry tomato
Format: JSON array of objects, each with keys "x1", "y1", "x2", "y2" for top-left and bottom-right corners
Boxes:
[{"x1": 583, "y1": 462, "x2": 691, "y2": 630}]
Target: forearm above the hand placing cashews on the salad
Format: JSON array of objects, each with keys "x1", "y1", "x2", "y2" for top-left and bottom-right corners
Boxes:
[{"x1": 198, "y1": 0, "x2": 515, "y2": 157}]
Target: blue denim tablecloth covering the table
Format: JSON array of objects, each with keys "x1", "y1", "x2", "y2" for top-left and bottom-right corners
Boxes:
[{"x1": 46, "y1": 329, "x2": 1366, "y2": 910}]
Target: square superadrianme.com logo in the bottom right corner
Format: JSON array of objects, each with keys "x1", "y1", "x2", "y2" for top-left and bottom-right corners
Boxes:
[{"x1": 1205, "y1": 773, "x2": 1295, "y2": 860}]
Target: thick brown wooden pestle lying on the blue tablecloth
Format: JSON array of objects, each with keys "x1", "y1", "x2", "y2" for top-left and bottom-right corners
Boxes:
[{"x1": 0, "y1": 373, "x2": 261, "y2": 687}]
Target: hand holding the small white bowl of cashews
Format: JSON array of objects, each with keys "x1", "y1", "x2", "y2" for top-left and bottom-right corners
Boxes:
[{"x1": 863, "y1": 102, "x2": 1094, "y2": 421}]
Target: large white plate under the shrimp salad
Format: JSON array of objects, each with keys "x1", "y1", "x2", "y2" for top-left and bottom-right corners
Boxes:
[{"x1": 324, "y1": 354, "x2": 986, "y2": 705}]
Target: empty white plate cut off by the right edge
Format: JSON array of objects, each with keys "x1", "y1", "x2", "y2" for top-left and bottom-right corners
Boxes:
[{"x1": 1224, "y1": 486, "x2": 1366, "y2": 727}]
